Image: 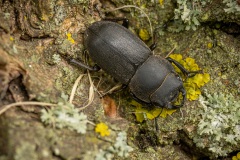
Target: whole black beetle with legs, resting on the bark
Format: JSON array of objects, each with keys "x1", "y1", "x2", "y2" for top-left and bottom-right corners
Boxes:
[{"x1": 72, "y1": 20, "x2": 199, "y2": 109}]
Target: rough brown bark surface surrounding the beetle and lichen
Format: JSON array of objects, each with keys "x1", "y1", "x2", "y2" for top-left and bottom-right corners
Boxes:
[{"x1": 0, "y1": 0, "x2": 240, "y2": 160}]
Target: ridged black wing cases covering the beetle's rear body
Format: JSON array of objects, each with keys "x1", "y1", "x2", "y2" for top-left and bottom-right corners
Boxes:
[{"x1": 84, "y1": 21, "x2": 151, "y2": 84}]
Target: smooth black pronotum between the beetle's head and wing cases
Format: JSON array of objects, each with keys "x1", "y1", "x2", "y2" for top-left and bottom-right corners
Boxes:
[{"x1": 129, "y1": 56, "x2": 174, "y2": 103}]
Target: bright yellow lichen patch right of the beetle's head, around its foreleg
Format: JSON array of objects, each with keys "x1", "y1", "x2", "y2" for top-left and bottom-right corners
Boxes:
[{"x1": 169, "y1": 54, "x2": 210, "y2": 101}]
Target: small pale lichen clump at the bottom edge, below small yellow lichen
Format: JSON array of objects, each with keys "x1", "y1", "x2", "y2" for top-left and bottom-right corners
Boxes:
[{"x1": 95, "y1": 132, "x2": 133, "y2": 160}]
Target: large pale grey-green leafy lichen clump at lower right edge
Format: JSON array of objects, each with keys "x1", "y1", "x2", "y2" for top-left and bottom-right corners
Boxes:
[{"x1": 193, "y1": 93, "x2": 240, "y2": 156}]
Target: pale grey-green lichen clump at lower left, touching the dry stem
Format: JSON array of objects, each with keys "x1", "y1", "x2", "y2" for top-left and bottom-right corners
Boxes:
[{"x1": 41, "y1": 102, "x2": 88, "y2": 134}]
